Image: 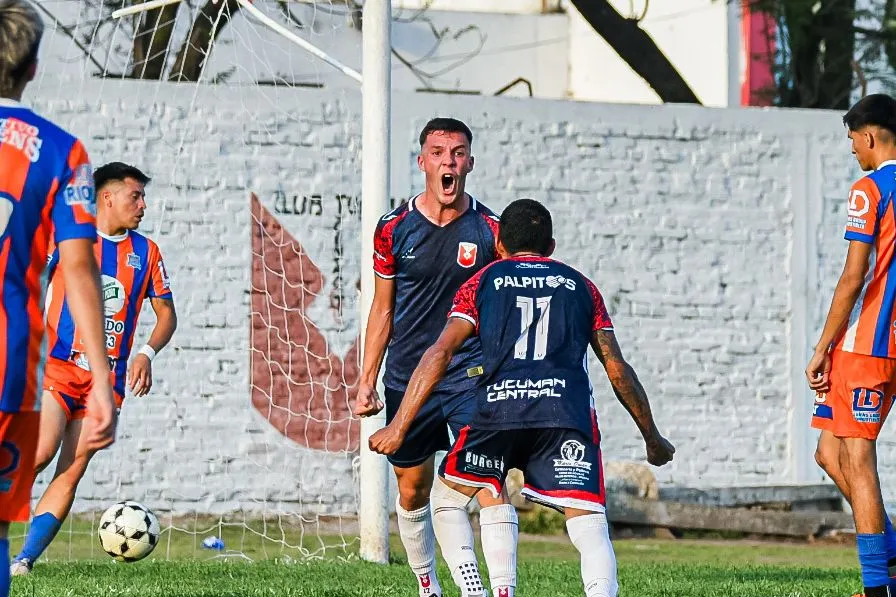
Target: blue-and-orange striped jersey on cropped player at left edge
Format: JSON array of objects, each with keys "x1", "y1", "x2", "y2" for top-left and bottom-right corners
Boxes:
[{"x1": 0, "y1": 99, "x2": 96, "y2": 412}]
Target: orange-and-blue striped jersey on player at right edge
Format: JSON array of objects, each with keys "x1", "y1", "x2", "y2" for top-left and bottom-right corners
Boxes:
[{"x1": 835, "y1": 161, "x2": 896, "y2": 358}]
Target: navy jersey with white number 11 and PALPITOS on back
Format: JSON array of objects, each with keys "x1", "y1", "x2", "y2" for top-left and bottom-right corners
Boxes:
[{"x1": 450, "y1": 256, "x2": 613, "y2": 440}]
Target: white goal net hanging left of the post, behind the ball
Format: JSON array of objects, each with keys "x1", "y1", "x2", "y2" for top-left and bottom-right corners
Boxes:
[{"x1": 22, "y1": 0, "x2": 376, "y2": 560}]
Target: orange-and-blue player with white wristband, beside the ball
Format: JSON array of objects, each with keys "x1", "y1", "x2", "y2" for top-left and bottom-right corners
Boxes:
[{"x1": 12, "y1": 162, "x2": 177, "y2": 575}]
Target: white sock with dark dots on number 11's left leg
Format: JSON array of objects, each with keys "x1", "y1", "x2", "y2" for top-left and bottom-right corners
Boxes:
[{"x1": 430, "y1": 477, "x2": 486, "y2": 597}]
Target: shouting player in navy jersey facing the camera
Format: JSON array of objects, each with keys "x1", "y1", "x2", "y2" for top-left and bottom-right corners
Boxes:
[{"x1": 354, "y1": 118, "x2": 518, "y2": 597}]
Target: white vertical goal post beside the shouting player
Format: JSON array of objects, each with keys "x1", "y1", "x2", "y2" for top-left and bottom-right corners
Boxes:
[{"x1": 358, "y1": 0, "x2": 392, "y2": 564}]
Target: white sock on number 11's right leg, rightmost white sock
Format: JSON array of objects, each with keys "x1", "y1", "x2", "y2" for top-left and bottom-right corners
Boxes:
[{"x1": 566, "y1": 513, "x2": 619, "y2": 597}]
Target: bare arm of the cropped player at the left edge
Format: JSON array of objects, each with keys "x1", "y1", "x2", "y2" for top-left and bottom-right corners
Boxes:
[{"x1": 59, "y1": 238, "x2": 117, "y2": 451}]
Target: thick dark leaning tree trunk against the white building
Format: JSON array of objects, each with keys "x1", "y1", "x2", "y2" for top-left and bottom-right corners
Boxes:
[{"x1": 572, "y1": 0, "x2": 701, "y2": 104}]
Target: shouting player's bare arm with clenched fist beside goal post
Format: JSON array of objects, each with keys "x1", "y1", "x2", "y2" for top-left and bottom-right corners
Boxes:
[{"x1": 353, "y1": 276, "x2": 395, "y2": 417}]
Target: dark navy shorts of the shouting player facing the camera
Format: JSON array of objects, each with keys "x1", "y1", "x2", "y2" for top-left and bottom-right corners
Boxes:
[{"x1": 385, "y1": 388, "x2": 476, "y2": 468}]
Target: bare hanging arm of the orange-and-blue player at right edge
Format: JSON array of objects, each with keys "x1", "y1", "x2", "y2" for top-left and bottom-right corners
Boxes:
[{"x1": 806, "y1": 240, "x2": 873, "y2": 393}]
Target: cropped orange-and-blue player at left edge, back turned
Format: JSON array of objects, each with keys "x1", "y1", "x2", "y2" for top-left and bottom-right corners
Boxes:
[{"x1": 0, "y1": 0, "x2": 116, "y2": 597}]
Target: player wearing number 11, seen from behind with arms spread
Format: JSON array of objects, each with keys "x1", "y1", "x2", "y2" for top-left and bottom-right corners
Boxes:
[{"x1": 370, "y1": 199, "x2": 675, "y2": 597}]
